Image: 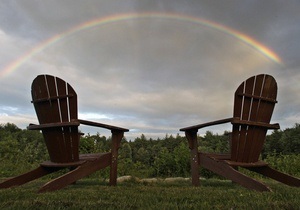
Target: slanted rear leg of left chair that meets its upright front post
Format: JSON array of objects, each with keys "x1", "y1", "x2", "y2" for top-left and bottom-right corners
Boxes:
[{"x1": 39, "y1": 153, "x2": 111, "y2": 193}]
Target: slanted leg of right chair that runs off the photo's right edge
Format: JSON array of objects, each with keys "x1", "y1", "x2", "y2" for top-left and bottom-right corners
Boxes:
[{"x1": 247, "y1": 166, "x2": 300, "y2": 187}]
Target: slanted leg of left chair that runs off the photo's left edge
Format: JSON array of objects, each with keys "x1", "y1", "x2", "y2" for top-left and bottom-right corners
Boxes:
[{"x1": 0, "y1": 166, "x2": 58, "y2": 188}]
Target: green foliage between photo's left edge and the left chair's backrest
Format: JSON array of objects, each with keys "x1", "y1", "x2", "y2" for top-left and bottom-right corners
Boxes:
[{"x1": 0, "y1": 123, "x2": 48, "y2": 177}]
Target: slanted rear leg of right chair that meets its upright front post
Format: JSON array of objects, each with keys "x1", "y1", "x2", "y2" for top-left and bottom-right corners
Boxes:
[{"x1": 199, "y1": 153, "x2": 272, "y2": 191}]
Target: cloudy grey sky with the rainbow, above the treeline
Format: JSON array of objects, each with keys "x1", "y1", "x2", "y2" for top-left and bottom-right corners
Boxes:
[{"x1": 0, "y1": 0, "x2": 300, "y2": 139}]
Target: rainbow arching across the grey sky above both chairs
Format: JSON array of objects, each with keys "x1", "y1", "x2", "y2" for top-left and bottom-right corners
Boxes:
[{"x1": 0, "y1": 12, "x2": 281, "y2": 78}]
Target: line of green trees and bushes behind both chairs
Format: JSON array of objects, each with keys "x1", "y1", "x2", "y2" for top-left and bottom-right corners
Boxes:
[{"x1": 0, "y1": 123, "x2": 300, "y2": 178}]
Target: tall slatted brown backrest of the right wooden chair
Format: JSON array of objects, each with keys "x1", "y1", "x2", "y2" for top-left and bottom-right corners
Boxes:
[{"x1": 231, "y1": 74, "x2": 277, "y2": 163}]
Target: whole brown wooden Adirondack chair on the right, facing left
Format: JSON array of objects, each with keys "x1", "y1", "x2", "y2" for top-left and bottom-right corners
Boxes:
[{"x1": 180, "y1": 74, "x2": 300, "y2": 191}]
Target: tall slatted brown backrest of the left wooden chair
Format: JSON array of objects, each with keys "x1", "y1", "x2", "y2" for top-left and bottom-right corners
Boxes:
[{"x1": 31, "y1": 75, "x2": 80, "y2": 163}]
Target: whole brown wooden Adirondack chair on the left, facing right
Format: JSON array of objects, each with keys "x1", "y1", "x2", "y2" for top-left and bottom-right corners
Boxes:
[{"x1": 0, "y1": 75, "x2": 129, "y2": 192}]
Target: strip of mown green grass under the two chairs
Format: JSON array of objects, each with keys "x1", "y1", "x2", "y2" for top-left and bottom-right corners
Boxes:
[{"x1": 0, "y1": 179, "x2": 300, "y2": 210}]
